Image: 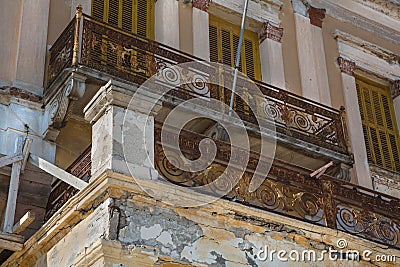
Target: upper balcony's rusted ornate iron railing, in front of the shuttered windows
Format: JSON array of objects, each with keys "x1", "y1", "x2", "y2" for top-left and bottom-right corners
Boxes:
[{"x1": 47, "y1": 15, "x2": 348, "y2": 154}]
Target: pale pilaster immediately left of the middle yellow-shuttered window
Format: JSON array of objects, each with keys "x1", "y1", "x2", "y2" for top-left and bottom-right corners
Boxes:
[{"x1": 192, "y1": 0, "x2": 210, "y2": 61}]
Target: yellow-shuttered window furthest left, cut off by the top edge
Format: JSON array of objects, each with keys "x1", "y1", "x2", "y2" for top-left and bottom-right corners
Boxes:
[{"x1": 92, "y1": 0, "x2": 154, "y2": 39}]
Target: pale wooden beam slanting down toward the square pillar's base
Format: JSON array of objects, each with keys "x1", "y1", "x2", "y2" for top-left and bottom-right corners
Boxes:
[{"x1": 29, "y1": 154, "x2": 88, "y2": 190}]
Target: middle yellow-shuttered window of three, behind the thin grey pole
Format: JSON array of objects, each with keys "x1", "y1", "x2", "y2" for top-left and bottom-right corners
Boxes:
[{"x1": 209, "y1": 16, "x2": 261, "y2": 80}]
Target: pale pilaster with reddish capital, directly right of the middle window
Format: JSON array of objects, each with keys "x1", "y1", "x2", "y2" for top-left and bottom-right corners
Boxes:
[{"x1": 259, "y1": 22, "x2": 286, "y2": 89}]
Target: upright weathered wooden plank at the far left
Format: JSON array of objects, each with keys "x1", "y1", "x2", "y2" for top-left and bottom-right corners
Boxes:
[{"x1": 3, "y1": 136, "x2": 24, "y2": 233}]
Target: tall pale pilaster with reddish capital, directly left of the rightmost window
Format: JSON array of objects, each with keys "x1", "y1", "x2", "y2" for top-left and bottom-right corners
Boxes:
[{"x1": 338, "y1": 57, "x2": 372, "y2": 189}]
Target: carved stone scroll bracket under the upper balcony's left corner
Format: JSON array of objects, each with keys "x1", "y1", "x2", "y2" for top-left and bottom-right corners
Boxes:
[{"x1": 43, "y1": 73, "x2": 86, "y2": 142}]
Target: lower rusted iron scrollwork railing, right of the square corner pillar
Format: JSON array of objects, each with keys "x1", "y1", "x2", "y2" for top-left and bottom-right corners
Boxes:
[{"x1": 155, "y1": 126, "x2": 400, "y2": 248}]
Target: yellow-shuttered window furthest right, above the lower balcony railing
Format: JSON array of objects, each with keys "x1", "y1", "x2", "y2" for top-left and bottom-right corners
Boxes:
[{"x1": 356, "y1": 78, "x2": 400, "y2": 172}]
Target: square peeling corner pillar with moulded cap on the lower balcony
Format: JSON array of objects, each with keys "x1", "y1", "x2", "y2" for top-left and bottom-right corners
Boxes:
[{"x1": 84, "y1": 81, "x2": 157, "y2": 182}]
